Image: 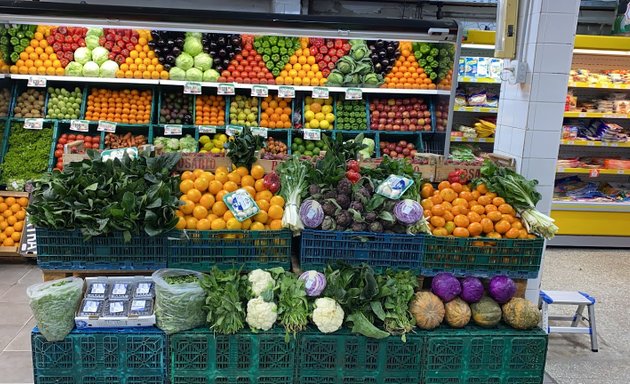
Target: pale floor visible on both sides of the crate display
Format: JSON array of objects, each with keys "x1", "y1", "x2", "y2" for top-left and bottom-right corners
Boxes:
[{"x1": 0, "y1": 248, "x2": 630, "y2": 384}]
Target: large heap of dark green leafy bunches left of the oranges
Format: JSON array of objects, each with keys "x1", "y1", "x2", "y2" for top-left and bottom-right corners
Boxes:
[{"x1": 28, "y1": 151, "x2": 180, "y2": 242}]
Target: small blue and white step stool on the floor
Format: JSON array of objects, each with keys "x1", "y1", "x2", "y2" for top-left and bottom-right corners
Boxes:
[{"x1": 540, "y1": 290, "x2": 597, "y2": 352}]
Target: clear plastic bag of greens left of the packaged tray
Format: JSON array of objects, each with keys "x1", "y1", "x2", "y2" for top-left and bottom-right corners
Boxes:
[{"x1": 26, "y1": 277, "x2": 83, "y2": 341}]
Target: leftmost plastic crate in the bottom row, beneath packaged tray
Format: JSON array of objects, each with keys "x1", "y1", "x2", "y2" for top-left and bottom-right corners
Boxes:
[{"x1": 31, "y1": 328, "x2": 167, "y2": 384}]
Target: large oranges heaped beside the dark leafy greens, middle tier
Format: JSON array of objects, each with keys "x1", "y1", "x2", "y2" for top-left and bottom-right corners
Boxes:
[{"x1": 176, "y1": 165, "x2": 284, "y2": 231}]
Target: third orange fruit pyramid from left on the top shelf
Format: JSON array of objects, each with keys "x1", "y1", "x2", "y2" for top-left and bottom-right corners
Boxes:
[{"x1": 276, "y1": 37, "x2": 326, "y2": 86}]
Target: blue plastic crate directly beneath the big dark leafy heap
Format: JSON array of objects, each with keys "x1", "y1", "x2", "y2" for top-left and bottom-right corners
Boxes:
[{"x1": 36, "y1": 228, "x2": 168, "y2": 271}]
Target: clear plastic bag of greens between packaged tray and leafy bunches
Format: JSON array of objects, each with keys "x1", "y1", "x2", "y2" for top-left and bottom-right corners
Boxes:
[{"x1": 152, "y1": 268, "x2": 206, "y2": 335}]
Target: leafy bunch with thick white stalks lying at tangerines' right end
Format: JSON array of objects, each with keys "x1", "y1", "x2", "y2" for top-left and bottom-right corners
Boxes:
[{"x1": 473, "y1": 160, "x2": 558, "y2": 239}]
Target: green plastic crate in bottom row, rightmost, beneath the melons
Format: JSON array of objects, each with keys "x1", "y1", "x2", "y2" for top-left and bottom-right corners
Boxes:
[{"x1": 420, "y1": 326, "x2": 547, "y2": 384}]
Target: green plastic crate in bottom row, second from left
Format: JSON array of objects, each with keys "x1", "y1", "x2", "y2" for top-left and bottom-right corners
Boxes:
[{"x1": 169, "y1": 327, "x2": 297, "y2": 384}]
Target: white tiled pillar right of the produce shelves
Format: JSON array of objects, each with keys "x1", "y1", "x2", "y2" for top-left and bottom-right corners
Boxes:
[{"x1": 494, "y1": 0, "x2": 580, "y2": 302}]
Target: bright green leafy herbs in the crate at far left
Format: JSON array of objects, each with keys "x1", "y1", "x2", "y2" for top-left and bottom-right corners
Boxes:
[{"x1": 0, "y1": 123, "x2": 53, "y2": 190}]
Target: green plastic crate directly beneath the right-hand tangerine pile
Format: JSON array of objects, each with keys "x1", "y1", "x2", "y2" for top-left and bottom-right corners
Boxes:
[{"x1": 422, "y1": 236, "x2": 545, "y2": 279}]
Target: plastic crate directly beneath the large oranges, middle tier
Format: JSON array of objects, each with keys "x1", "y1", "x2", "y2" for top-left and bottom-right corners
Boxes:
[{"x1": 168, "y1": 230, "x2": 292, "y2": 271}]
